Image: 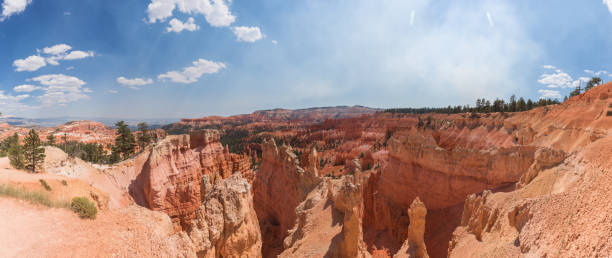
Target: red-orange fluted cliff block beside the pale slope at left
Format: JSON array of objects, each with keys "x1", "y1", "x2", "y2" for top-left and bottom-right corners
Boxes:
[{"x1": 137, "y1": 130, "x2": 252, "y2": 229}]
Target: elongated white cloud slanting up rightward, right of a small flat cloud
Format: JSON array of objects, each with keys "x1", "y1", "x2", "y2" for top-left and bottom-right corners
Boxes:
[{"x1": 157, "y1": 58, "x2": 225, "y2": 83}]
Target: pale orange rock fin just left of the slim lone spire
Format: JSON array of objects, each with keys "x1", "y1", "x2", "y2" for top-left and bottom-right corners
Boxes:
[{"x1": 280, "y1": 176, "x2": 371, "y2": 257}]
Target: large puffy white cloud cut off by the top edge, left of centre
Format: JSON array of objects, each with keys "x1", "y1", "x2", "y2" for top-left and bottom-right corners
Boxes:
[{"x1": 147, "y1": 0, "x2": 236, "y2": 27}]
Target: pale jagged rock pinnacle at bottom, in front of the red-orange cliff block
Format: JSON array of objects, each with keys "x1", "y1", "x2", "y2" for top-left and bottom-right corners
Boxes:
[{"x1": 188, "y1": 174, "x2": 262, "y2": 258}]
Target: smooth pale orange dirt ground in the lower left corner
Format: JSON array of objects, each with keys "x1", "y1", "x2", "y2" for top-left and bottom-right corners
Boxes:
[{"x1": 0, "y1": 197, "x2": 191, "y2": 257}]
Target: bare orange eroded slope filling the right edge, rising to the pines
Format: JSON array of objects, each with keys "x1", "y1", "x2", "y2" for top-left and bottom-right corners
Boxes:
[{"x1": 448, "y1": 84, "x2": 612, "y2": 257}]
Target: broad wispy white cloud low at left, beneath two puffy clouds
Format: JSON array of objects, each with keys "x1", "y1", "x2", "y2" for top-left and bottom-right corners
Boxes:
[{"x1": 28, "y1": 74, "x2": 91, "y2": 106}]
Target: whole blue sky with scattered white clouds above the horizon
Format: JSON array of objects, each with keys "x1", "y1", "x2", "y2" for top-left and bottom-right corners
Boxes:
[{"x1": 0, "y1": 0, "x2": 612, "y2": 118}]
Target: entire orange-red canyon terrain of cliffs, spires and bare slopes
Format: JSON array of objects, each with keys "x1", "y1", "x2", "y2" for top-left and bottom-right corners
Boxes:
[{"x1": 0, "y1": 84, "x2": 612, "y2": 257}]
